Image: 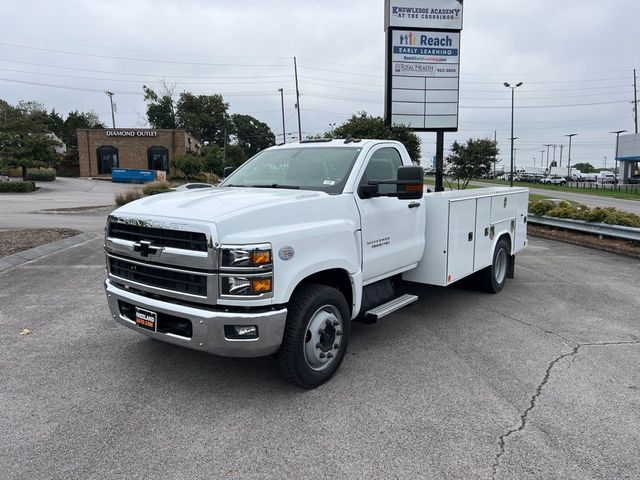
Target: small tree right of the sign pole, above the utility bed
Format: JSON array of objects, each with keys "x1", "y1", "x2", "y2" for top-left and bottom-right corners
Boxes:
[{"x1": 447, "y1": 138, "x2": 499, "y2": 189}]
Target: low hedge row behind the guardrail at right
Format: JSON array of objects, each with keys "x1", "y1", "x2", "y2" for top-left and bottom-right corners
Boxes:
[{"x1": 529, "y1": 200, "x2": 640, "y2": 228}]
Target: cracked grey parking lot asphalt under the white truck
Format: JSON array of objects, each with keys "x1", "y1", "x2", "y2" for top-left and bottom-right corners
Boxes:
[{"x1": 0, "y1": 234, "x2": 640, "y2": 480}]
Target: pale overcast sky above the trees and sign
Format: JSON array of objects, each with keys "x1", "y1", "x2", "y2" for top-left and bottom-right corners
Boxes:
[{"x1": 0, "y1": 0, "x2": 640, "y2": 171}]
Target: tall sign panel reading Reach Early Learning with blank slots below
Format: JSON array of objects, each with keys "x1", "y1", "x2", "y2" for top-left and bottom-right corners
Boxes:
[{"x1": 387, "y1": 30, "x2": 460, "y2": 131}]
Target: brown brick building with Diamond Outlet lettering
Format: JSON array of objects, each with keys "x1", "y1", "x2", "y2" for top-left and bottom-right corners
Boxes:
[{"x1": 77, "y1": 128, "x2": 202, "y2": 177}]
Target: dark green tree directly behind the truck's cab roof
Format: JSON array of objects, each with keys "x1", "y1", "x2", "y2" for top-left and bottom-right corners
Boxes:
[{"x1": 324, "y1": 112, "x2": 421, "y2": 163}]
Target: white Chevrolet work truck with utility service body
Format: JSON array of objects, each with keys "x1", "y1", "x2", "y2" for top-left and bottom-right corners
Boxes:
[{"x1": 105, "y1": 139, "x2": 528, "y2": 388}]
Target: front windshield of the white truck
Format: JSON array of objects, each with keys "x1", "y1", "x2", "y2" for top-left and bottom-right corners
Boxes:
[{"x1": 220, "y1": 147, "x2": 362, "y2": 194}]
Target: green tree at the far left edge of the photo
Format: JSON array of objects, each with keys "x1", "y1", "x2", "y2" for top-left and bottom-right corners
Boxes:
[{"x1": 0, "y1": 100, "x2": 57, "y2": 180}]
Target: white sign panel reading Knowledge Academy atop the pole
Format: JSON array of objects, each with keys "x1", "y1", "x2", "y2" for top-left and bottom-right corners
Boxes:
[{"x1": 385, "y1": 0, "x2": 462, "y2": 30}]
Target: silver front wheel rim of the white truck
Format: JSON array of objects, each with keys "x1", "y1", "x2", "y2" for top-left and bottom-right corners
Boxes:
[{"x1": 304, "y1": 305, "x2": 343, "y2": 371}]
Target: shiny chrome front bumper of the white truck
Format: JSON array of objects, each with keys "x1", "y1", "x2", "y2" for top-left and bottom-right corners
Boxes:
[{"x1": 104, "y1": 279, "x2": 287, "y2": 357}]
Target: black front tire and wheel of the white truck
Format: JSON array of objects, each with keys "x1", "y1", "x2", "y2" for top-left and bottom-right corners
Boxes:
[{"x1": 276, "y1": 284, "x2": 351, "y2": 389}]
